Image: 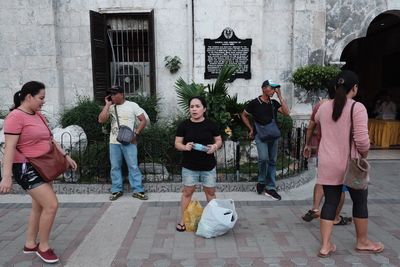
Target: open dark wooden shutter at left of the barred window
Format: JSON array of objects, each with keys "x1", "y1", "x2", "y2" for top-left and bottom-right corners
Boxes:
[{"x1": 89, "y1": 10, "x2": 110, "y2": 103}]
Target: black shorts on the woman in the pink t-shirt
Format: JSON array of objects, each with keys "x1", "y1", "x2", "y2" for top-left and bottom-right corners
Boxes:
[{"x1": 13, "y1": 163, "x2": 46, "y2": 190}]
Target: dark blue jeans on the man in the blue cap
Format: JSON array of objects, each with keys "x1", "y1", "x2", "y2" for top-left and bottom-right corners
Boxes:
[{"x1": 255, "y1": 134, "x2": 279, "y2": 190}]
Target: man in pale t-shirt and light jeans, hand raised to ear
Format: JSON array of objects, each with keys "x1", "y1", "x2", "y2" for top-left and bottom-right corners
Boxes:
[{"x1": 99, "y1": 86, "x2": 148, "y2": 201}]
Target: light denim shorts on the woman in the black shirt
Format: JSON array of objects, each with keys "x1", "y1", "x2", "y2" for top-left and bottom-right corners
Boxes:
[{"x1": 182, "y1": 168, "x2": 217, "y2": 187}]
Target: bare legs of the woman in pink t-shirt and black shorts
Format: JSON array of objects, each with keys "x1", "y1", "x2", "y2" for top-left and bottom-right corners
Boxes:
[{"x1": 25, "y1": 184, "x2": 58, "y2": 251}]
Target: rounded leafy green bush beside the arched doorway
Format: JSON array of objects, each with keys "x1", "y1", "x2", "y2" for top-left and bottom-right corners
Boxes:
[{"x1": 291, "y1": 65, "x2": 340, "y2": 102}]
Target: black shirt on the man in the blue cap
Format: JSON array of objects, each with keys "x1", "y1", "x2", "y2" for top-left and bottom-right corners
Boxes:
[{"x1": 245, "y1": 97, "x2": 281, "y2": 125}]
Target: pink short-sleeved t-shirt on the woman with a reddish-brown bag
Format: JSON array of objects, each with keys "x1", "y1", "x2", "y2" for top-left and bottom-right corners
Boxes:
[{"x1": 4, "y1": 109, "x2": 50, "y2": 163}]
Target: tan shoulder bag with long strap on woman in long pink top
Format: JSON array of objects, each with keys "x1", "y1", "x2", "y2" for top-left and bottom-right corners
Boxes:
[{"x1": 344, "y1": 102, "x2": 371, "y2": 190}]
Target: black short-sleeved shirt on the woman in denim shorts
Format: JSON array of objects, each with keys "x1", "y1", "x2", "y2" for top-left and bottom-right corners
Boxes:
[{"x1": 176, "y1": 119, "x2": 221, "y2": 171}]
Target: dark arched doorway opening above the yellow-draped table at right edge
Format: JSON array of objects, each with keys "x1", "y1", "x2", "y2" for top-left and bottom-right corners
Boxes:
[{"x1": 340, "y1": 10, "x2": 400, "y2": 118}]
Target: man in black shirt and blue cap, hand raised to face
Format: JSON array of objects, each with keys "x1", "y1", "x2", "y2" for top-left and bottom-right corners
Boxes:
[{"x1": 241, "y1": 80, "x2": 289, "y2": 200}]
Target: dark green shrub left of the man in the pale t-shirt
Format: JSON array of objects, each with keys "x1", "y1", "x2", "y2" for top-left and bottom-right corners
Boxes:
[{"x1": 61, "y1": 97, "x2": 105, "y2": 141}]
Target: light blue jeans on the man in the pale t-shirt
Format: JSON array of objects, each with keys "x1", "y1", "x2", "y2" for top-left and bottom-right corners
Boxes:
[{"x1": 110, "y1": 144, "x2": 144, "y2": 193}]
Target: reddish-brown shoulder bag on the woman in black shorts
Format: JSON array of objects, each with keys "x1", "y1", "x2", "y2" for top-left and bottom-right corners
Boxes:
[{"x1": 18, "y1": 115, "x2": 69, "y2": 182}]
